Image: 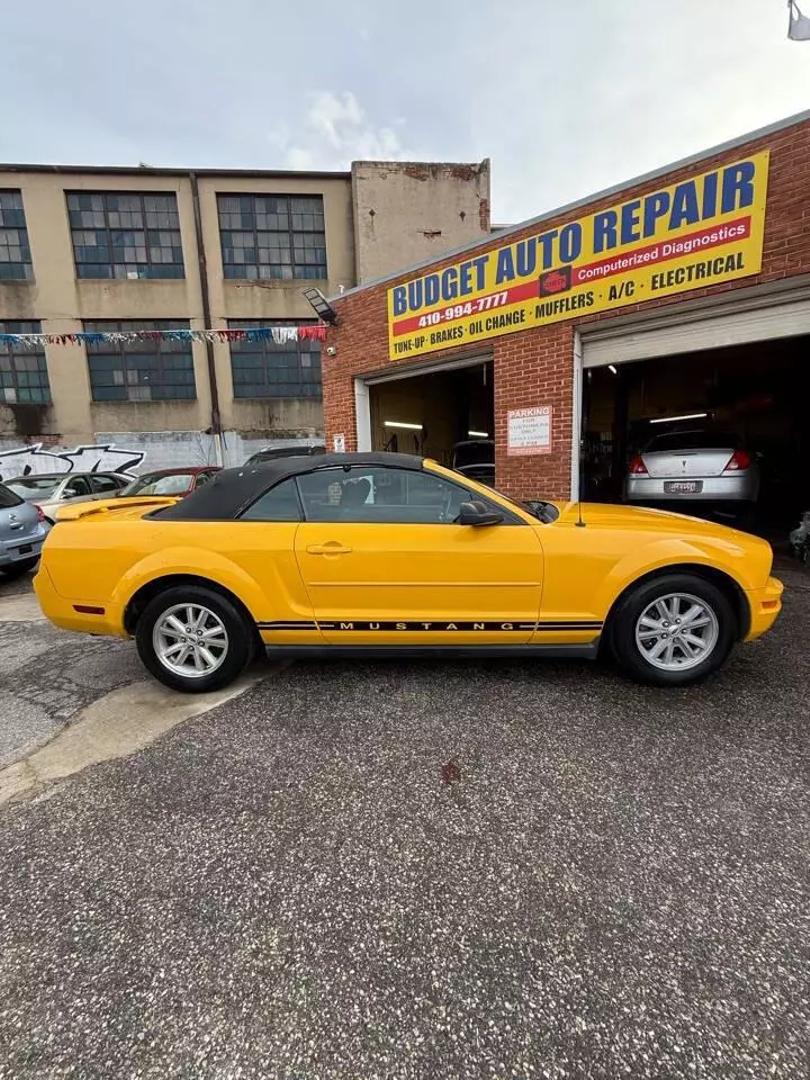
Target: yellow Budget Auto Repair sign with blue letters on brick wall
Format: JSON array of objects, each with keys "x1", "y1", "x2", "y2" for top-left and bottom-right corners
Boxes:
[{"x1": 388, "y1": 150, "x2": 768, "y2": 360}]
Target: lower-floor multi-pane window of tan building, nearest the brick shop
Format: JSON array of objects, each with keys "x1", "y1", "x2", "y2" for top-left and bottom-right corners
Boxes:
[{"x1": 228, "y1": 320, "x2": 322, "y2": 406}]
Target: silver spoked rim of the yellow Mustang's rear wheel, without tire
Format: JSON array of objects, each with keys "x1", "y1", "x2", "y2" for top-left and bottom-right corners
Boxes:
[{"x1": 152, "y1": 604, "x2": 228, "y2": 678}]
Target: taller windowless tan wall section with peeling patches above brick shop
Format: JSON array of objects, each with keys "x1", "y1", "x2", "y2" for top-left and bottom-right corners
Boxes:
[{"x1": 352, "y1": 158, "x2": 490, "y2": 283}]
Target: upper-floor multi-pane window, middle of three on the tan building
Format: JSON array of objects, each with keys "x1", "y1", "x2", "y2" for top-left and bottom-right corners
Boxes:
[{"x1": 67, "y1": 191, "x2": 184, "y2": 279}]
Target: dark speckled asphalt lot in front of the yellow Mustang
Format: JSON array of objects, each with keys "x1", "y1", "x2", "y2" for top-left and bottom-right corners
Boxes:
[{"x1": 0, "y1": 571, "x2": 810, "y2": 1080}]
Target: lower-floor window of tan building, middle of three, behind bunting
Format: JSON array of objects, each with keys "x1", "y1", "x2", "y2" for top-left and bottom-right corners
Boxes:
[{"x1": 84, "y1": 319, "x2": 197, "y2": 402}]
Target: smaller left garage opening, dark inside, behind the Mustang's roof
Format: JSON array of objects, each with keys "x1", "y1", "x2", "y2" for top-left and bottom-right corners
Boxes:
[{"x1": 368, "y1": 361, "x2": 495, "y2": 483}]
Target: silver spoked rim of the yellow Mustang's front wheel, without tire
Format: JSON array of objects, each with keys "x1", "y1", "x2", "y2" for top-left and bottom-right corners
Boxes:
[{"x1": 636, "y1": 593, "x2": 720, "y2": 671}]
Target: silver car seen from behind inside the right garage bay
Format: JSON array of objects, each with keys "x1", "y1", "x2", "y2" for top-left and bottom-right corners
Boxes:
[{"x1": 624, "y1": 429, "x2": 759, "y2": 518}]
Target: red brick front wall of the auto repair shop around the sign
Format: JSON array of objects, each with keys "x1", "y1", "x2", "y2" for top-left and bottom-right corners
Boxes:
[{"x1": 323, "y1": 120, "x2": 810, "y2": 498}]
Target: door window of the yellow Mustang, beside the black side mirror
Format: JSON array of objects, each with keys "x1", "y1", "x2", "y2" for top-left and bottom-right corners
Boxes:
[{"x1": 298, "y1": 465, "x2": 470, "y2": 525}]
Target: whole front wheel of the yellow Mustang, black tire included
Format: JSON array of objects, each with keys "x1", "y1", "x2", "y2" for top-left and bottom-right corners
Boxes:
[{"x1": 608, "y1": 573, "x2": 738, "y2": 686}]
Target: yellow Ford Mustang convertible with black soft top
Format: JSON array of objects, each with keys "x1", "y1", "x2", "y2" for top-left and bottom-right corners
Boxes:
[{"x1": 35, "y1": 454, "x2": 782, "y2": 692}]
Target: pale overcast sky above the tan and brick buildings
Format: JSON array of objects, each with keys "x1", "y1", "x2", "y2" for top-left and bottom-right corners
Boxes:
[{"x1": 6, "y1": 0, "x2": 810, "y2": 222}]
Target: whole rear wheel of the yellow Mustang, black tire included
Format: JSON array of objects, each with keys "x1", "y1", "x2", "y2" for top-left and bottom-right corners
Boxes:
[{"x1": 135, "y1": 585, "x2": 255, "y2": 693}]
